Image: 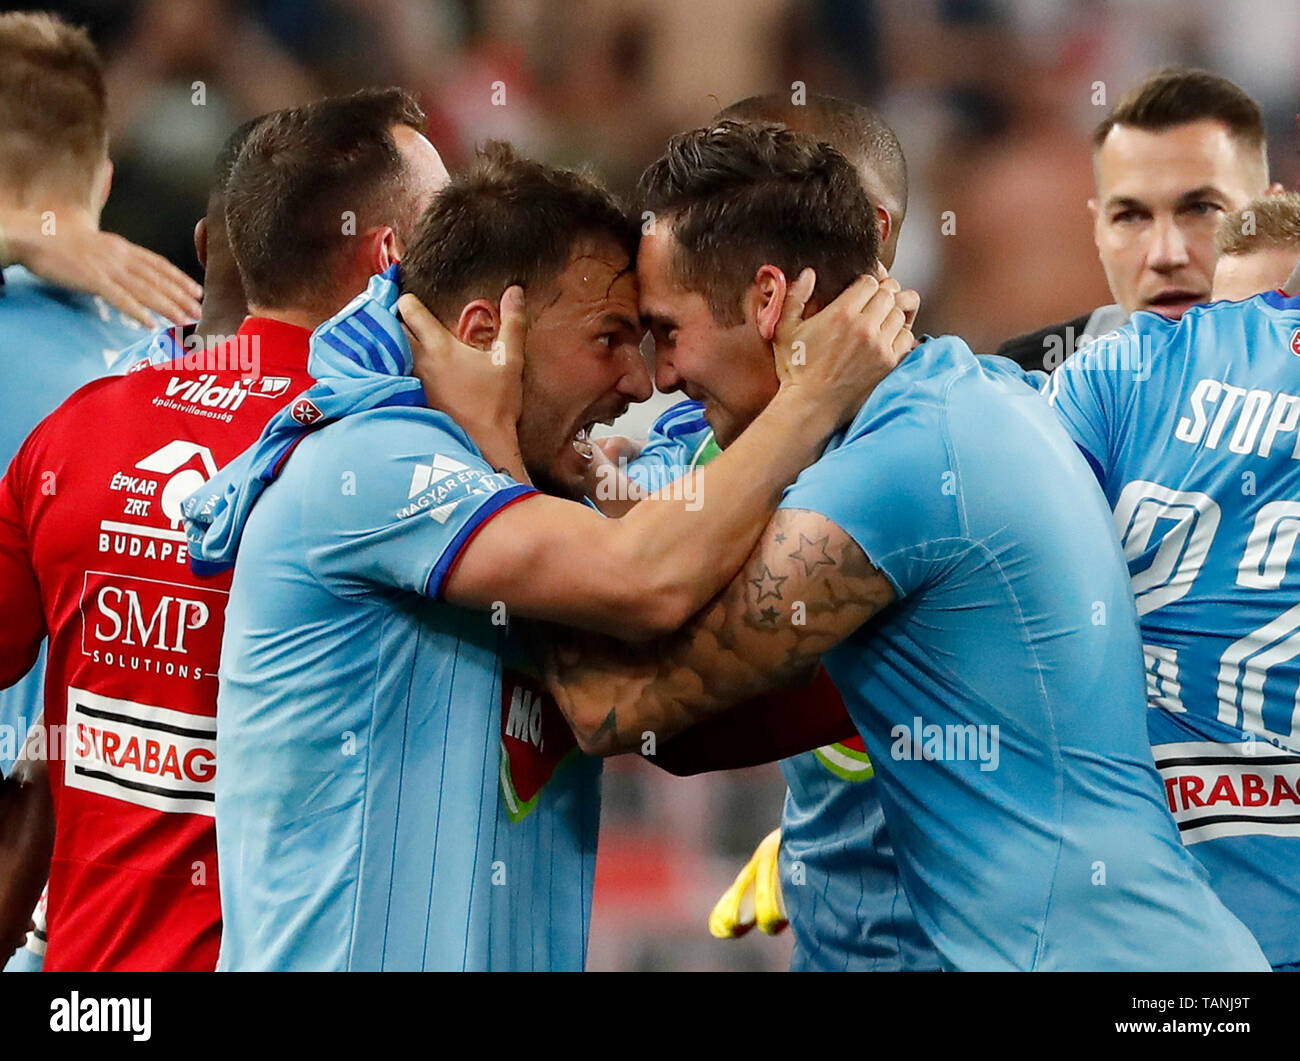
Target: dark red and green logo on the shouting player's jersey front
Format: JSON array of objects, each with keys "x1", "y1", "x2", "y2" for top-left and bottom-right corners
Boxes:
[{"x1": 501, "y1": 670, "x2": 577, "y2": 822}]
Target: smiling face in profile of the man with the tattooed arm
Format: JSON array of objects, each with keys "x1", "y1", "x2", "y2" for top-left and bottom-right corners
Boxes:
[{"x1": 637, "y1": 224, "x2": 780, "y2": 447}]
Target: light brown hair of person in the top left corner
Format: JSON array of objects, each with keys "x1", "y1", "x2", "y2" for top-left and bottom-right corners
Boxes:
[{"x1": 0, "y1": 12, "x2": 108, "y2": 207}]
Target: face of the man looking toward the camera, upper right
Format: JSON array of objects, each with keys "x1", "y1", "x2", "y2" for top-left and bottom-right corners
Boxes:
[{"x1": 1088, "y1": 121, "x2": 1268, "y2": 320}]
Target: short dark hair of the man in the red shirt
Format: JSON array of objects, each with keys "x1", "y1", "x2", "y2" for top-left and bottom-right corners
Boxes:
[{"x1": 226, "y1": 88, "x2": 425, "y2": 308}]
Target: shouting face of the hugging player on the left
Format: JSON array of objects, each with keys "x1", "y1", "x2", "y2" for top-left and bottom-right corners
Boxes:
[{"x1": 519, "y1": 239, "x2": 653, "y2": 499}]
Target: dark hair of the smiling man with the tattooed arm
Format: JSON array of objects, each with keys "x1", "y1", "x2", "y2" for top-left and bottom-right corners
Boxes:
[{"x1": 637, "y1": 121, "x2": 880, "y2": 325}]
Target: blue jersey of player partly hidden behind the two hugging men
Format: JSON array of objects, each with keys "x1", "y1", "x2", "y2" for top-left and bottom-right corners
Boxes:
[{"x1": 628, "y1": 402, "x2": 940, "y2": 971}]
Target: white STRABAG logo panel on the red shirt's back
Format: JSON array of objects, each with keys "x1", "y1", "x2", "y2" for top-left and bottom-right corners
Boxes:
[{"x1": 64, "y1": 687, "x2": 217, "y2": 817}]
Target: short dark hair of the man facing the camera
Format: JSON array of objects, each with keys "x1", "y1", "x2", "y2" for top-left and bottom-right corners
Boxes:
[{"x1": 1092, "y1": 66, "x2": 1266, "y2": 157}]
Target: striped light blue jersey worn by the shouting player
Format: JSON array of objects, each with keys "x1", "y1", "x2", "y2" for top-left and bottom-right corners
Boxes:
[{"x1": 217, "y1": 406, "x2": 598, "y2": 970}]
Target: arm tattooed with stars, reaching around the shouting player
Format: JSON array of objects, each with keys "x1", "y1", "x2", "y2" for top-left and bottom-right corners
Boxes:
[{"x1": 546, "y1": 508, "x2": 894, "y2": 755}]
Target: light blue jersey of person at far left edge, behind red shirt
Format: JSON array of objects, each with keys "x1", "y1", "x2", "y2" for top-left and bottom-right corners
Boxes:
[{"x1": 0, "y1": 265, "x2": 146, "y2": 774}]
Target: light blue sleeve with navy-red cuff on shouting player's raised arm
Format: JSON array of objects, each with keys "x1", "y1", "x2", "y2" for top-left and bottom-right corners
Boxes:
[{"x1": 304, "y1": 408, "x2": 537, "y2": 597}]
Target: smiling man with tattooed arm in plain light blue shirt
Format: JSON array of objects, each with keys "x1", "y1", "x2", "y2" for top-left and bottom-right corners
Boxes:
[{"x1": 533, "y1": 122, "x2": 1265, "y2": 969}]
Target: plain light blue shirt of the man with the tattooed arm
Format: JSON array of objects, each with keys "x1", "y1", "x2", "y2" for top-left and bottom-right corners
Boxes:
[{"x1": 781, "y1": 337, "x2": 1266, "y2": 970}]
